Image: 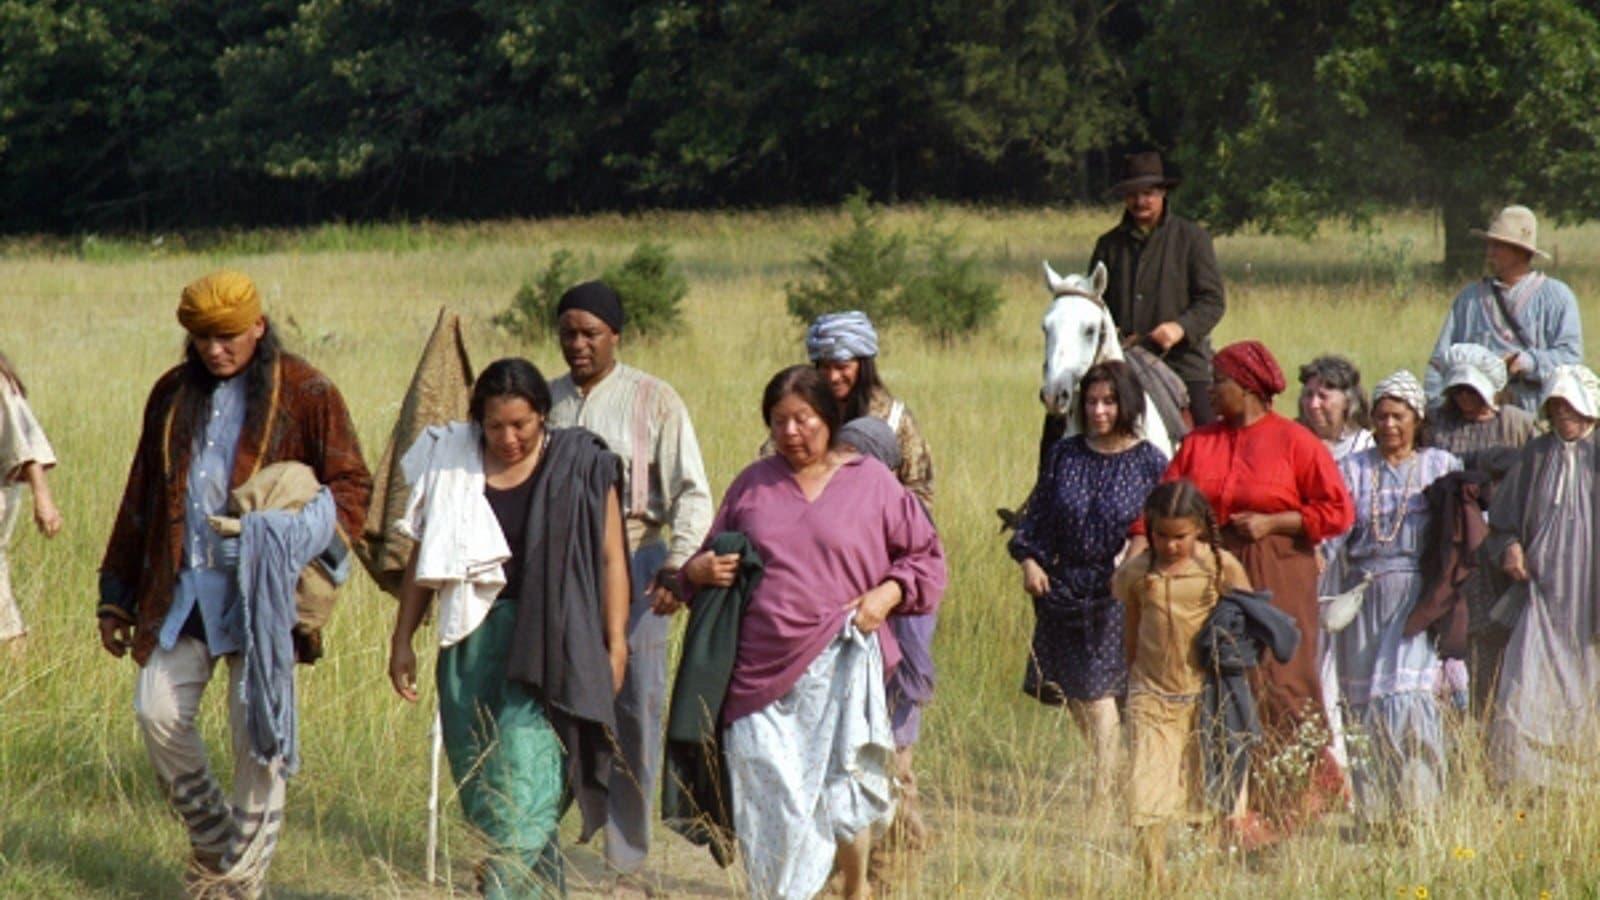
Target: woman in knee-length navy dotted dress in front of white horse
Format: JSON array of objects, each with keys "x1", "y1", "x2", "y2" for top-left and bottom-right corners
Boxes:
[{"x1": 1010, "y1": 362, "x2": 1166, "y2": 809}]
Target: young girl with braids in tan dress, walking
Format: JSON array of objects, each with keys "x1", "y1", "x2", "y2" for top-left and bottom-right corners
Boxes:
[{"x1": 1112, "y1": 480, "x2": 1250, "y2": 882}]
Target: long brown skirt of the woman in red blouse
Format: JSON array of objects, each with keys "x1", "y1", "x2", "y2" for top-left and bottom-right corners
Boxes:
[{"x1": 1222, "y1": 528, "x2": 1344, "y2": 828}]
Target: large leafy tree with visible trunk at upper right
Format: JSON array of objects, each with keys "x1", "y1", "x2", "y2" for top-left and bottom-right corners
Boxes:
[{"x1": 1141, "y1": 0, "x2": 1600, "y2": 267}]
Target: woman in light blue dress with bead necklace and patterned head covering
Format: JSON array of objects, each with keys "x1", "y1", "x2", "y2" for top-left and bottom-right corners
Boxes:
[{"x1": 1331, "y1": 370, "x2": 1461, "y2": 822}]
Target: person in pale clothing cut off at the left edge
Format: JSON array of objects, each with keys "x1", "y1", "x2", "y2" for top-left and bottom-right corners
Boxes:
[{"x1": 0, "y1": 347, "x2": 61, "y2": 655}]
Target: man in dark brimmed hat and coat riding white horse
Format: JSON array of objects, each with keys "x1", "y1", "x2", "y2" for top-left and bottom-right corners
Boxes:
[{"x1": 1090, "y1": 152, "x2": 1224, "y2": 426}]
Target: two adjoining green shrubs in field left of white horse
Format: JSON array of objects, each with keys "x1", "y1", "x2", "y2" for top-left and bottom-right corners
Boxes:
[{"x1": 787, "y1": 192, "x2": 1000, "y2": 343}]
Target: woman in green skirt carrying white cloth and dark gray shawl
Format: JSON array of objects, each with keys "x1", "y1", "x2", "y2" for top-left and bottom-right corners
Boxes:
[{"x1": 389, "y1": 359, "x2": 630, "y2": 898}]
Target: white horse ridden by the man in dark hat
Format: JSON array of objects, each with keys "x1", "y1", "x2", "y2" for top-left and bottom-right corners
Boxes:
[{"x1": 1038, "y1": 261, "x2": 1174, "y2": 458}]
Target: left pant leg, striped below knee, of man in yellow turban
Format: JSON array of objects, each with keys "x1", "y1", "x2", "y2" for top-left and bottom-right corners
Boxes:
[{"x1": 133, "y1": 637, "x2": 238, "y2": 866}]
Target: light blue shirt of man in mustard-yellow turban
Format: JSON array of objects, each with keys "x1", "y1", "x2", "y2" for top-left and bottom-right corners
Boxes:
[{"x1": 160, "y1": 378, "x2": 245, "y2": 657}]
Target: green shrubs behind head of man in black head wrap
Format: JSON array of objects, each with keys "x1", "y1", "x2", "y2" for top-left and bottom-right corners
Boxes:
[{"x1": 494, "y1": 242, "x2": 690, "y2": 341}]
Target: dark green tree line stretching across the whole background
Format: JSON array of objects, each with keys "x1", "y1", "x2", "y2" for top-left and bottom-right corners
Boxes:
[{"x1": 9, "y1": 0, "x2": 1600, "y2": 265}]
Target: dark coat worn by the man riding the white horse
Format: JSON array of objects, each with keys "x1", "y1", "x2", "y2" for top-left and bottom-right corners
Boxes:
[{"x1": 1090, "y1": 213, "x2": 1224, "y2": 381}]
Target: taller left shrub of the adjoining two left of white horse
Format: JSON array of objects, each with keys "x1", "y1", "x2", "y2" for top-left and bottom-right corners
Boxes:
[{"x1": 786, "y1": 191, "x2": 909, "y2": 323}]
